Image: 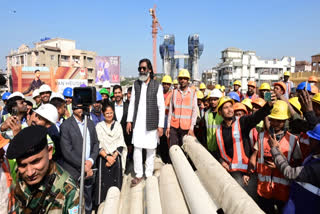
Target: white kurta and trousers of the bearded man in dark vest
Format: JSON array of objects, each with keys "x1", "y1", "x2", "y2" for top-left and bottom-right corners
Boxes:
[{"x1": 127, "y1": 58, "x2": 165, "y2": 186}]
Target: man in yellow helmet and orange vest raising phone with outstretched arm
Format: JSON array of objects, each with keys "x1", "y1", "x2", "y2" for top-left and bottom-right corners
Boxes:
[{"x1": 216, "y1": 94, "x2": 275, "y2": 202}]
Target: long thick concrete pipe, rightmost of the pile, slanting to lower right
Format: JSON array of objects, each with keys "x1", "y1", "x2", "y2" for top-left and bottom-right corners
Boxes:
[{"x1": 183, "y1": 136, "x2": 263, "y2": 214}]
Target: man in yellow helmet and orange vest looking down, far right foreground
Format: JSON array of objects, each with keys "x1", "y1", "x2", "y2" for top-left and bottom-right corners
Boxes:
[{"x1": 249, "y1": 100, "x2": 301, "y2": 213}]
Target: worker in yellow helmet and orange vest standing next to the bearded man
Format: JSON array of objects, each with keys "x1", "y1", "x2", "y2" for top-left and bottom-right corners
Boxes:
[{"x1": 166, "y1": 69, "x2": 198, "y2": 146}]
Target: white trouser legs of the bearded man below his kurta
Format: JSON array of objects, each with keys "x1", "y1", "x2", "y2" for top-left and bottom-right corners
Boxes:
[{"x1": 133, "y1": 147, "x2": 156, "y2": 178}]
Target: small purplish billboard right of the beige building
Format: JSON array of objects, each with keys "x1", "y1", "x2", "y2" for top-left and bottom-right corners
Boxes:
[{"x1": 96, "y1": 56, "x2": 120, "y2": 85}]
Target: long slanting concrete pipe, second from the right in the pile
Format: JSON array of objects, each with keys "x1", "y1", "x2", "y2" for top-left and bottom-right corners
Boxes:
[{"x1": 169, "y1": 145, "x2": 218, "y2": 214}]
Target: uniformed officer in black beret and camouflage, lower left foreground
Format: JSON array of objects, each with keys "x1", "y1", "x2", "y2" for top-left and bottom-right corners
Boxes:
[{"x1": 7, "y1": 126, "x2": 79, "y2": 214}]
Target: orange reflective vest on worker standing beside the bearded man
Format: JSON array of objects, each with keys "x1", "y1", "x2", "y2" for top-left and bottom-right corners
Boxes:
[{"x1": 170, "y1": 89, "x2": 195, "y2": 130}]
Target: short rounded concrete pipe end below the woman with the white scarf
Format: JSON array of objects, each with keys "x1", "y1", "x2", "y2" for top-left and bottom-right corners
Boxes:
[{"x1": 103, "y1": 186, "x2": 120, "y2": 214}]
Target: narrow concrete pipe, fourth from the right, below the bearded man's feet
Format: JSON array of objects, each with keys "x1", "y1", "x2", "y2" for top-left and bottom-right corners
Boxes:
[{"x1": 146, "y1": 176, "x2": 162, "y2": 214}]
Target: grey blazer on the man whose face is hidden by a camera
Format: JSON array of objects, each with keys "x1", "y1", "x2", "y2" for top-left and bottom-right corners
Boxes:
[{"x1": 60, "y1": 116, "x2": 99, "y2": 181}]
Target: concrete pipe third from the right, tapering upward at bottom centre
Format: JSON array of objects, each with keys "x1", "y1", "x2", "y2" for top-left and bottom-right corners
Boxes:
[{"x1": 159, "y1": 164, "x2": 189, "y2": 214}]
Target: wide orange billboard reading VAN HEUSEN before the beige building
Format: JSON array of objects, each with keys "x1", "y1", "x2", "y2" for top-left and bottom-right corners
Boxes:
[{"x1": 11, "y1": 66, "x2": 88, "y2": 96}]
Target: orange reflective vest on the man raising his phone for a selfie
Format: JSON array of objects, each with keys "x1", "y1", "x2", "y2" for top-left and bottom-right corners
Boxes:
[{"x1": 216, "y1": 119, "x2": 249, "y2": 172}]
